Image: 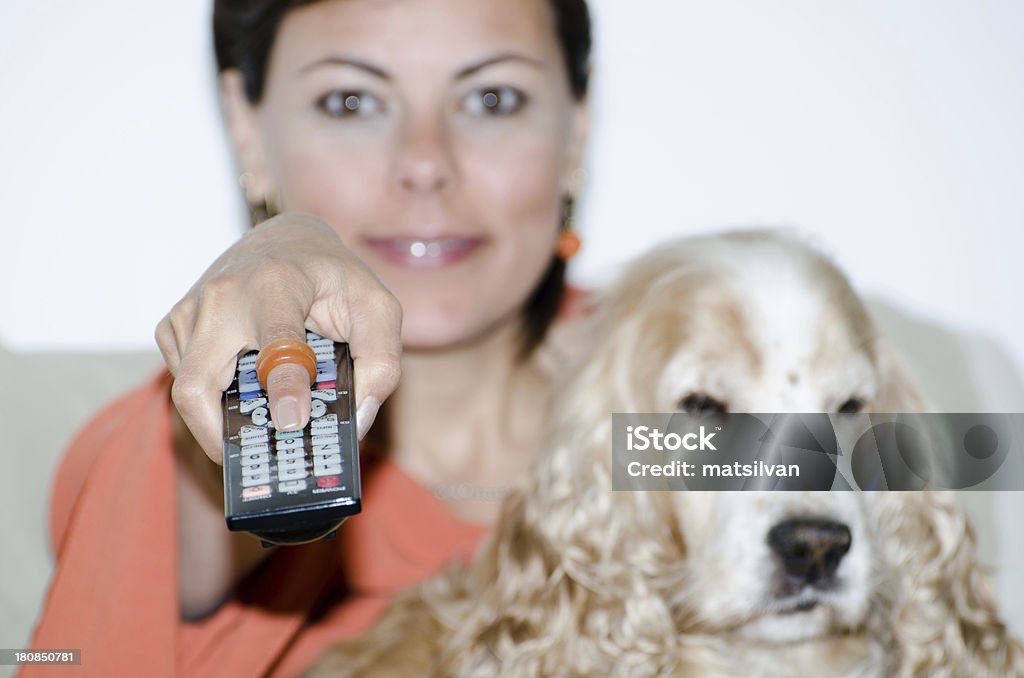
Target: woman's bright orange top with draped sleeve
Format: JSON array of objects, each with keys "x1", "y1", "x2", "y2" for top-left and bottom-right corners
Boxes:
[{"x1": 20, "y1": 372, "x2": 487, "y2": 678}]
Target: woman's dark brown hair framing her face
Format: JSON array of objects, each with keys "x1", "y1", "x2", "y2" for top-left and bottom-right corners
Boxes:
[{"x1": 213, "y1": 0, "x2": 591, "y2": 357}]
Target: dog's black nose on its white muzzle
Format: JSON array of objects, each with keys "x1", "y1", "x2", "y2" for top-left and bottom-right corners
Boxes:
[{"x1": 768, "y1": 518, "x2": 851, "y2": 585}]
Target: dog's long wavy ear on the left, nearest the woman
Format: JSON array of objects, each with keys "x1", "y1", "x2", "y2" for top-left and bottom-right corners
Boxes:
[{"x1": 423, "y1": 278, "x2": 683, "y2": 675}]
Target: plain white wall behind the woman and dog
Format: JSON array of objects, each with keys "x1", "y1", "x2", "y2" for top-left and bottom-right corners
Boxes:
[{"x1": 0, "y1": 0, "x2": 1024, "y2": 639}]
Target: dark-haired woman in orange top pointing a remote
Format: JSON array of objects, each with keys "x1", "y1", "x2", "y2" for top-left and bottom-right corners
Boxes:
[{"x1": 25, "y1": 0, "x2": 590, "y2": 675}]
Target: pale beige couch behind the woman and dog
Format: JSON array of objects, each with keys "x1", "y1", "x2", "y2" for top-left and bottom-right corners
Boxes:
[{"x1": 0, "y1": 331, "x2": 1024, "y2": 678}]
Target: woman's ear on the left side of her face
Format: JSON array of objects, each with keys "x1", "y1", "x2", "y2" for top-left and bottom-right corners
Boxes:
[{"x1": 218, "y1": 69, "x2": 270, "y2": 203}]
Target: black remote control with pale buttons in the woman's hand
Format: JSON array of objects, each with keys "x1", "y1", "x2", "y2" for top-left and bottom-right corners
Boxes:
[{"x1": 223, "y1": 332, "x2": 362, "y2": 545}]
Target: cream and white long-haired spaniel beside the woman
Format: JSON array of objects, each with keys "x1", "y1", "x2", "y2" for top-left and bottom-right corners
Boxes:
[{"x1": 307, "y1": 230, "x2": 1024, "y2": 678}]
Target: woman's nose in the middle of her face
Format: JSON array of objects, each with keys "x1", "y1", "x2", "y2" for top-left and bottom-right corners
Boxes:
[{"x1": 397, "y1": 111, "x2": 456, "y2": 193}]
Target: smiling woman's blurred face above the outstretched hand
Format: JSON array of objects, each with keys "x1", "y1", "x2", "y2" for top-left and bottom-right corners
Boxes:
[{"x1": 223, "y1": 0, "x2": 586, "y2": 348}]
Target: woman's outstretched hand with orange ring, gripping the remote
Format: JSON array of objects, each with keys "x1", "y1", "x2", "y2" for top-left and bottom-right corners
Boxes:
[{"x1": 156, "y1": 213, "x2": 401, "y2": 464}]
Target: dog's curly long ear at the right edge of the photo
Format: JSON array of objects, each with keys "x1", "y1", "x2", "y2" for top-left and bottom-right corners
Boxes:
[{"x1": 876, "y1": 492, "x2": 1024, "y2": 676}]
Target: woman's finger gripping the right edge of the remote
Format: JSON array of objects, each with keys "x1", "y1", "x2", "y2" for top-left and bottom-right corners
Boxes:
[{"x1": 348, "y1": 288, "x2": 401, "y2": 439}]
